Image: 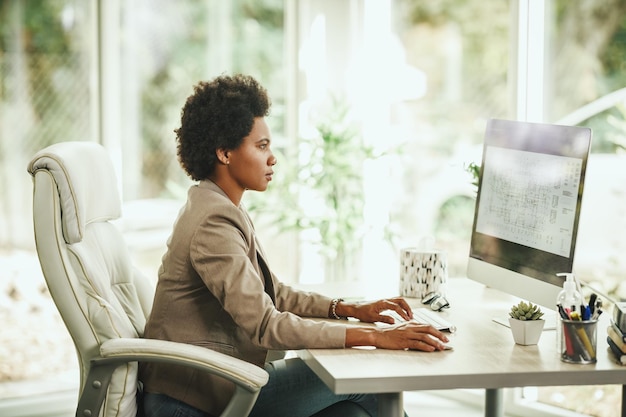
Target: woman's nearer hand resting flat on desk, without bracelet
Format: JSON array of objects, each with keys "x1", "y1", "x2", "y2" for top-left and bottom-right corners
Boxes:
[{"x1": 346, "y1": 322, "x2": 449, "y2": 352}]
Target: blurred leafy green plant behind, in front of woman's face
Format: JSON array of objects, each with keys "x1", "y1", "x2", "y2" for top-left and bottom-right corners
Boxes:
[{"x1": 246, "y1": 95, "x2": 377, "y2": 270}]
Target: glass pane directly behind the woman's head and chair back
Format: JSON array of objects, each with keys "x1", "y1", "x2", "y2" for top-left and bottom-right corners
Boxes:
[{"x1": 119, "y1": 0, "x2": 286, "y2": 279}]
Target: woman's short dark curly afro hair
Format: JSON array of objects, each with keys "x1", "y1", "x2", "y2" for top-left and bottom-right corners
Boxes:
[{"x1": 174, "y1": 74, "x2": 271, "y2": 181}]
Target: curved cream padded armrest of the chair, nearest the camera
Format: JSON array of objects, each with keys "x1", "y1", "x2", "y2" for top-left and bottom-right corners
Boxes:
[{"x1": 100, "y1": 338, "x2": 269, "y2": 392}]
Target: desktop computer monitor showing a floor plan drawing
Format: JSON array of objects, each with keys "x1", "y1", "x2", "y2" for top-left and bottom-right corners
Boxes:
[{"x1": 467, "y1": 119, "x2": 591, "y2": 310}]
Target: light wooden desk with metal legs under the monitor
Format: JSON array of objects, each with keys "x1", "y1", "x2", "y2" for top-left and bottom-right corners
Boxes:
[{"x1": 298, "y1": 278, "x2": 626, "y2": 417}]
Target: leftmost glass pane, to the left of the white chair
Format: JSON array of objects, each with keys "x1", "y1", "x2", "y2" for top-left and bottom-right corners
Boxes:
[{"x1": 0, "y1": 0, "x2": 97, "y2": 398}]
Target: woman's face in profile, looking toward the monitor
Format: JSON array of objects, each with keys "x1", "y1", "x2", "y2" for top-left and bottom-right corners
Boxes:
[{"x1": 227, "y1": 117, "x2": 276, "y2": 191}]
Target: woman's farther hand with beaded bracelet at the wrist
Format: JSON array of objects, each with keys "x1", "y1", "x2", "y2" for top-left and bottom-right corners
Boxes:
[{"x1": 336, "y1": 297, "x2": 413, "y2": 324}]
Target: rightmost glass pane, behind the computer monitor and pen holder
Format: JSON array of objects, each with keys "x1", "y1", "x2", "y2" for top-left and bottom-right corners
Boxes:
[{"x1": 536, "y1": 0, "x2": 626, "y2": 417}]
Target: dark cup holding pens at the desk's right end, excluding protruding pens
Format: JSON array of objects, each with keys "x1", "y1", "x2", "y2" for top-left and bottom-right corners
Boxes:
[{"x1": 559, "y1": 319, "x2": 598, "y2": 364}]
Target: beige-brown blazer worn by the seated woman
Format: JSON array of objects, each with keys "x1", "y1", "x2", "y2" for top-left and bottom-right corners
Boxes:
[{"x1": 140, "y1": 181, "x2": 345, "y2": 415}]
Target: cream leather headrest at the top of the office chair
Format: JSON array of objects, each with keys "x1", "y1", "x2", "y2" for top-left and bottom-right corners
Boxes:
[{"x1": 28, "y1": 142, "x2": 122, "y2": 244}]
